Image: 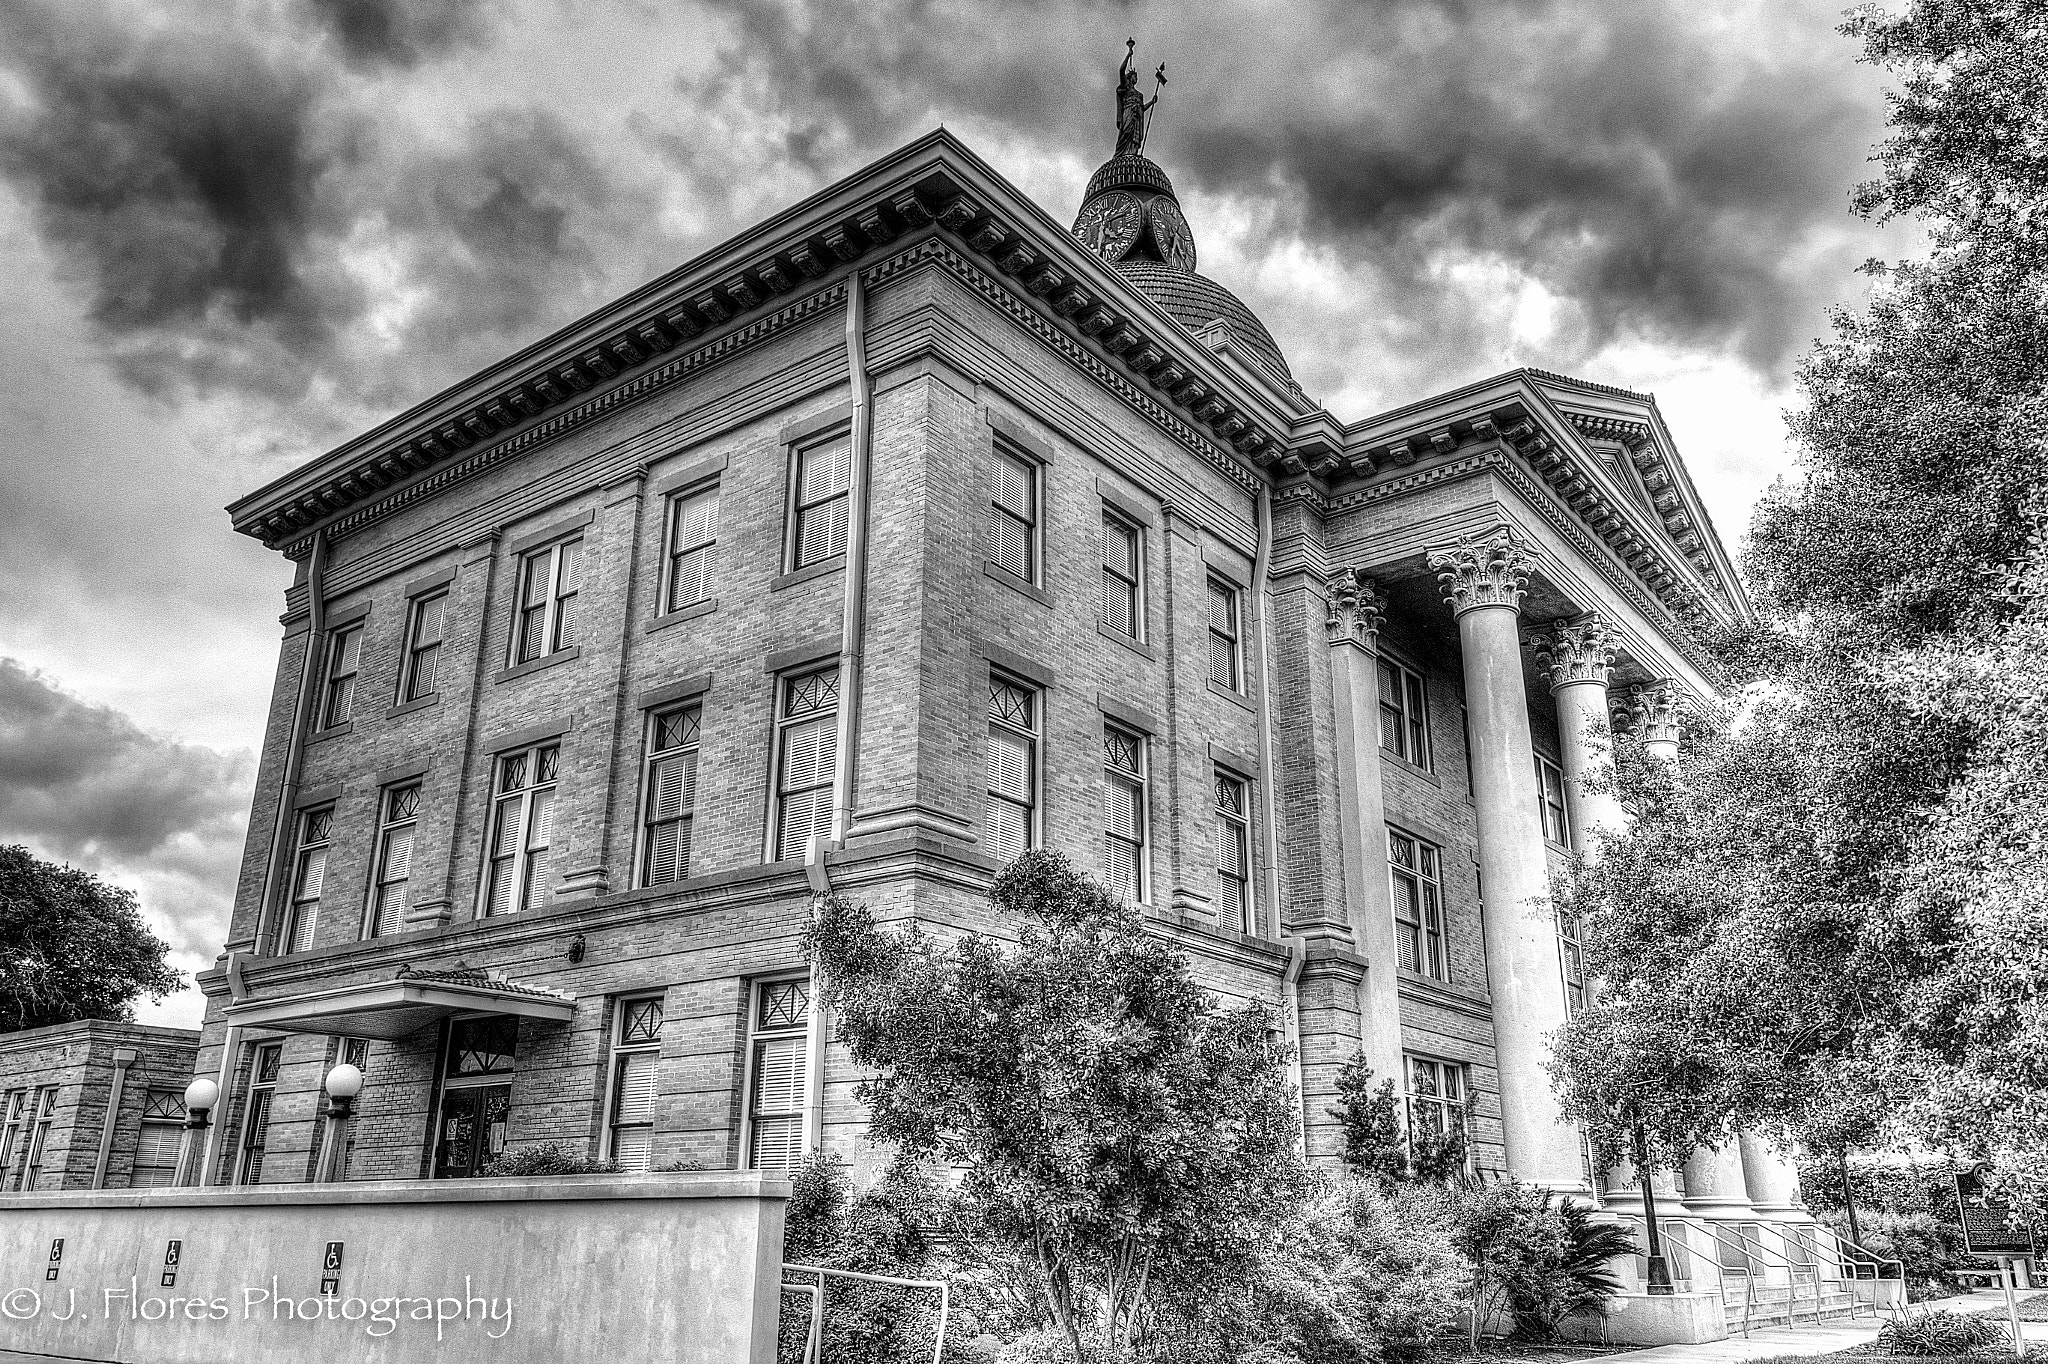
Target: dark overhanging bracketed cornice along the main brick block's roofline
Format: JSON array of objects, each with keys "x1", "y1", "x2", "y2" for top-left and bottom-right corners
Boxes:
[{"x1": 229, "y1": 131, "x2": 1303, "y2": 553}]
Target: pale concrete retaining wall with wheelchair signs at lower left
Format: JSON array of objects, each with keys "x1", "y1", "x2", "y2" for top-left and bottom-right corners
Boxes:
[{"x1": 0, "y1": 1174, "x2": 788, "y2": 1364}]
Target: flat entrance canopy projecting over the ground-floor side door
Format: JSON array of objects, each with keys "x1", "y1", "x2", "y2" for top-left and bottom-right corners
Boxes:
[{"x1": 223, "y1": 969, "x2": 575, "y2": 1042}]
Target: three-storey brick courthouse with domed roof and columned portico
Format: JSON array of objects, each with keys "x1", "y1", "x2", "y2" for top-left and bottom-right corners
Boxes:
[{"x1": 176, "y1": 114, "x2": 1796, "y2": 1245}]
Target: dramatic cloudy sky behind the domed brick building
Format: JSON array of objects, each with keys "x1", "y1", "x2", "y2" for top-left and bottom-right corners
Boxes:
[{"x1": 0, "y1": 0, "x2": 1915, "y2": 1024}]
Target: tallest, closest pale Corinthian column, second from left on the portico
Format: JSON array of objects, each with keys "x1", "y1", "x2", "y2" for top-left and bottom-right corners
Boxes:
[{"x1": 1430, "y1": 526, "x2": 1589, "y2": 1194}]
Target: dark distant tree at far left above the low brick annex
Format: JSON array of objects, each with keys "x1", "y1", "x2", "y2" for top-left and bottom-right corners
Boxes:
[{"x1": 0, "y1": 846, "x2": 184, "y2": 1032}]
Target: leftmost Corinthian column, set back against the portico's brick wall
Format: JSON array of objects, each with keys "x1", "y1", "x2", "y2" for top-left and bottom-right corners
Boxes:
[{"x1": 1329, "y1": 569, "x2": 1407, "y2": 1088}]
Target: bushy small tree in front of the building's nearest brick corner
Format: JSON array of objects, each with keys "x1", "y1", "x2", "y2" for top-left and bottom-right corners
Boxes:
[{"x1": 805, "y1": 852, "x2": 1309, "y2": 1360}]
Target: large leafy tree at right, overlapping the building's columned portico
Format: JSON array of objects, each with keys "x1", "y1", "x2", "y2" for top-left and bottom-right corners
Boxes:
[{"x1": 1556, "y1": 0, "x2": 2048, "y2": 1212}]
